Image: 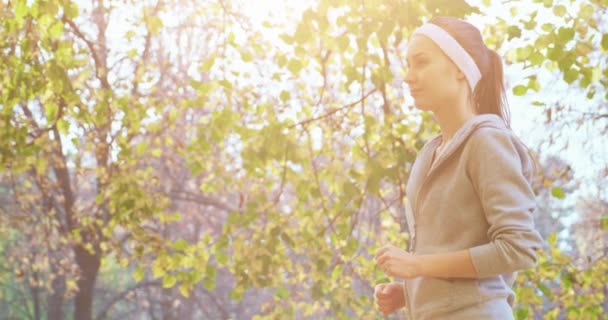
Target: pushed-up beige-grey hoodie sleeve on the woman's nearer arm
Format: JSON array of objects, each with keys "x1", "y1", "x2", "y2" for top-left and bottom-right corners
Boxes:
[{"x1": 468, "y1": 127, "x2": 543, "y2": 278}]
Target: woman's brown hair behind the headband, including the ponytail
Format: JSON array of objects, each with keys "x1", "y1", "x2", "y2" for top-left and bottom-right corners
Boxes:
[{"x1": 429, "y1": 17, "x2": 511, "y2": 127}]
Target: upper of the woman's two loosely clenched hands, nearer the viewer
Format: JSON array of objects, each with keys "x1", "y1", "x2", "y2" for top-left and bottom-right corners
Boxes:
[{"x1": 375, "y1": 244, "x2": 422, "y2": 279}]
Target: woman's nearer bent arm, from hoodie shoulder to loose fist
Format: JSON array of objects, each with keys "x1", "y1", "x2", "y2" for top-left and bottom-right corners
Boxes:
[{"x1": 376, "y1": 128, "x2": 543, "y2": 279}]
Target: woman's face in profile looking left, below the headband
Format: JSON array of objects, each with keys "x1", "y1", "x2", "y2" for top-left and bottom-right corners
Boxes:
[{"x1": 405, "y1": 35, "x2": 465, "y2": 112}]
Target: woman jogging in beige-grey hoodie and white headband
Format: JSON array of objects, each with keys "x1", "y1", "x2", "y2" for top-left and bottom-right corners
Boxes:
[{"x1": 374, "y1": 17, "x2": 543, "y2": 319}]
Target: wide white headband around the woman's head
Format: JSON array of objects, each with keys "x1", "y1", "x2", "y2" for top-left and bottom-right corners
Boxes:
[{"x1": 412, "y1": 23, "x2": 481, "y2": 91}]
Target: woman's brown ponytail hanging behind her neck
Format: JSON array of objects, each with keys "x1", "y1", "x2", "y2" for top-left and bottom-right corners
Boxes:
[{"x1": 473, "y1": 48, "x2": 511, "y2": 127}]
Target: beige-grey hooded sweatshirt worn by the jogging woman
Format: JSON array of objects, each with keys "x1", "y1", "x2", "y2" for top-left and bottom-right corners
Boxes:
[{"x1": 404, "y1": 114, "x2": 543, "y2": 319}]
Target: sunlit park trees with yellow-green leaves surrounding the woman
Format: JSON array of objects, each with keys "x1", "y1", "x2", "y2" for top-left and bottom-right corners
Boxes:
[{"x1": 0, "y1": 0, "x2": 608, "y2": 320}]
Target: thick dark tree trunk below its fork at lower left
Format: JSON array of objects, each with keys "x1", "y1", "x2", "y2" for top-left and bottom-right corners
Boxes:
[{"x1": 74, "y1": 245, "x2": 100, "y2": 320}]
